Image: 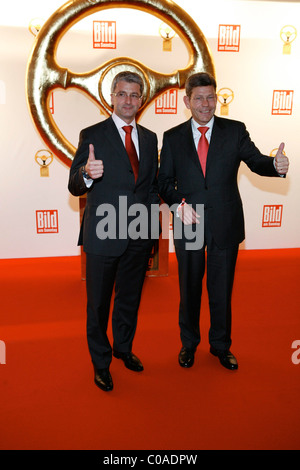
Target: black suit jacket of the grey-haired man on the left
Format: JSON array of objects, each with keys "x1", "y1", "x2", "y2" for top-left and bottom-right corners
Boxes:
[{"x1": 68, "y1": 117, "x2": 159, "y2": 256}]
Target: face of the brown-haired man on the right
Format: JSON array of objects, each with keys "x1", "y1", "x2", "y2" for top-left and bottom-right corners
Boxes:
[{"x1": 183, "y1": 85, "x2": 217, "y2": 126}]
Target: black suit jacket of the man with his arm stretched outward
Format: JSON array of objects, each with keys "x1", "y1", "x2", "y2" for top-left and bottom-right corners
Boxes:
[{"x1": 158, "y1": 116, "x2": 279, "y2": 248}]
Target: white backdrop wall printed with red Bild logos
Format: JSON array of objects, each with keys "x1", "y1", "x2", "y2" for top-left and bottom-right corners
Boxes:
[{"x1": 0, "y1": 0, "x2": 300, "y2": 258}]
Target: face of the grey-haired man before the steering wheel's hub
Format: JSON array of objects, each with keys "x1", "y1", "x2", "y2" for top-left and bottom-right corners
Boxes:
[{"x1": 111, "y1": 80, "x2": 142, "y2": 124}]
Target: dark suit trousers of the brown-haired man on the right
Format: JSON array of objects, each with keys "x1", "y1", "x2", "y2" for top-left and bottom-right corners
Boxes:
[{"x1": 175, "y1": 224, "x2": 238, "y2": 350}]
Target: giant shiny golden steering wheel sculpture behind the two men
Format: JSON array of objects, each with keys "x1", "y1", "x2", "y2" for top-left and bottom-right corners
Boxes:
[{"x1": 26, "y1": 0, "x2": 215, "y2": 166}]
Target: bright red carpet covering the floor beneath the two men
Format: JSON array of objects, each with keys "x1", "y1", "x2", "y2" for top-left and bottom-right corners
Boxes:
[{"x1": 0, "y1": 249, "x2": 300, "y2": 450}]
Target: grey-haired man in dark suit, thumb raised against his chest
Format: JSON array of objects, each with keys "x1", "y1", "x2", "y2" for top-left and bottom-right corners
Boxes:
[{"x1": 69, "y1": 71, "x2": 159, "y2": 391}]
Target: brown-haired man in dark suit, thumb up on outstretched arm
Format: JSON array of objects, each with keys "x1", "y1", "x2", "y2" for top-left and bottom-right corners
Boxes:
[{"x1": 158, "y1": 73, "x2": 289, "y2": 370}]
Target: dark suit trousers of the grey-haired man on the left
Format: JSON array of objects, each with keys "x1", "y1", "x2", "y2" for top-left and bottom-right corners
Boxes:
[{"x1": 86, "y1": 240, "x2": 152, "y2": 369}]
